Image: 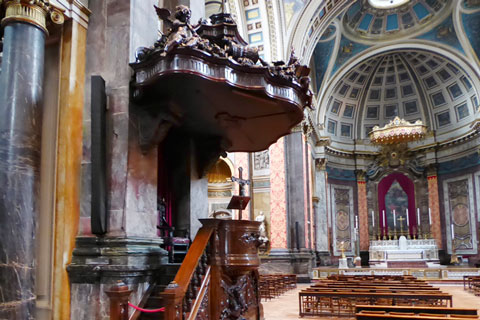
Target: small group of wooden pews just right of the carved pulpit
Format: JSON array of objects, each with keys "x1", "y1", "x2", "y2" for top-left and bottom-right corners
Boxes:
[{"x1": 259, "y1": 274, "x2": 297, "y2": 300}]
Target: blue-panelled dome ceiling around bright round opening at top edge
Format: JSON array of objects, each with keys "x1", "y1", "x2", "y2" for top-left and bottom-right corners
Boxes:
[{"x1": 343, "y1": 0, "x2": 448, "y2": 39}]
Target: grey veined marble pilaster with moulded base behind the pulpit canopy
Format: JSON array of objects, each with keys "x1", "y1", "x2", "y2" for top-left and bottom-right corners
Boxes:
[{"x1": 69, "y1": 0, "x2": 168, "y2": 319}]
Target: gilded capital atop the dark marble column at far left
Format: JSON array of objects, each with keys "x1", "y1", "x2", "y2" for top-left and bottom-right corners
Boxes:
[{"x1": 0, "y1": 0, "x2": 65, "y2": 33}]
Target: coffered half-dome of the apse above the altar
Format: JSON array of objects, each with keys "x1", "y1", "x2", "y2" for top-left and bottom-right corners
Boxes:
[{"x1": 324, "y1": 51, "x2": 478, "y2": 144}]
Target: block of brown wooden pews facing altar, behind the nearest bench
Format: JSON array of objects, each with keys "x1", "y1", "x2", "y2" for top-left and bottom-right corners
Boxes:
[{"x1": 299, "y1": 275, "x2": 452, "y2": 317}]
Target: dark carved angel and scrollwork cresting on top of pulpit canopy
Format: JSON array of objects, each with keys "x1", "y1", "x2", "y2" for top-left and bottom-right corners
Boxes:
[{"x1": 135, "y1": 5, "x2": 313, "y2": 107}]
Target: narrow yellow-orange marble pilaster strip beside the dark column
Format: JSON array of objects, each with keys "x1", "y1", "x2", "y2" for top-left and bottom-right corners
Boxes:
[{"x1": 53, "y1": 20, "x2": 87, "y2": 319}]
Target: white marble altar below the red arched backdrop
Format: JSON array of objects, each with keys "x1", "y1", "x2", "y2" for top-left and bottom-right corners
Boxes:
[{"x1": 369, "y1": 236, "x2": 438, "y2": 263}]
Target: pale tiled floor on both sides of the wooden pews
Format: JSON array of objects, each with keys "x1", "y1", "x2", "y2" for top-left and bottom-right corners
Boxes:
[{"x1": 263, "y1": 284, "x2": 480, "y2": 320}]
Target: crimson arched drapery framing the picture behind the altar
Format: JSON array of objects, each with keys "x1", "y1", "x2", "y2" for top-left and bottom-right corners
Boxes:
[{"x1": 378, "y1": 173, "x2": 417, "y2": 235}]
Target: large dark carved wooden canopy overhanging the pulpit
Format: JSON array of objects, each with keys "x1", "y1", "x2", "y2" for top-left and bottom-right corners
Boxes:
[{"x1": 131, "y1": 6, "x2": 312, "y2": 152}]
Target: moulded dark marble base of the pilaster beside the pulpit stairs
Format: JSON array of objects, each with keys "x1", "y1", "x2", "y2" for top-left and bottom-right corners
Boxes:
[{"x1": 67, "y1": 237, "x2": 171, "y2": 319}]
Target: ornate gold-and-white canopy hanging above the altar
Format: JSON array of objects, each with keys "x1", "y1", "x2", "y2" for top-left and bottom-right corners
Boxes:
[{"x1": 369, "y1": 117, "x2": 427, "y2": 145}]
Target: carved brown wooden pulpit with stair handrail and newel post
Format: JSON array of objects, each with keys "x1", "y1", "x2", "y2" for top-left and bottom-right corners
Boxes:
[{"x1": 106, "y1": 219, "x2": 263, "y2": 320}]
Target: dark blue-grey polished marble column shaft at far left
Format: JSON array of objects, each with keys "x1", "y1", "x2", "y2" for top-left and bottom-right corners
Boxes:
[{"x1": 0, "y1": 21, "x2": 45, "y2": 320}]
